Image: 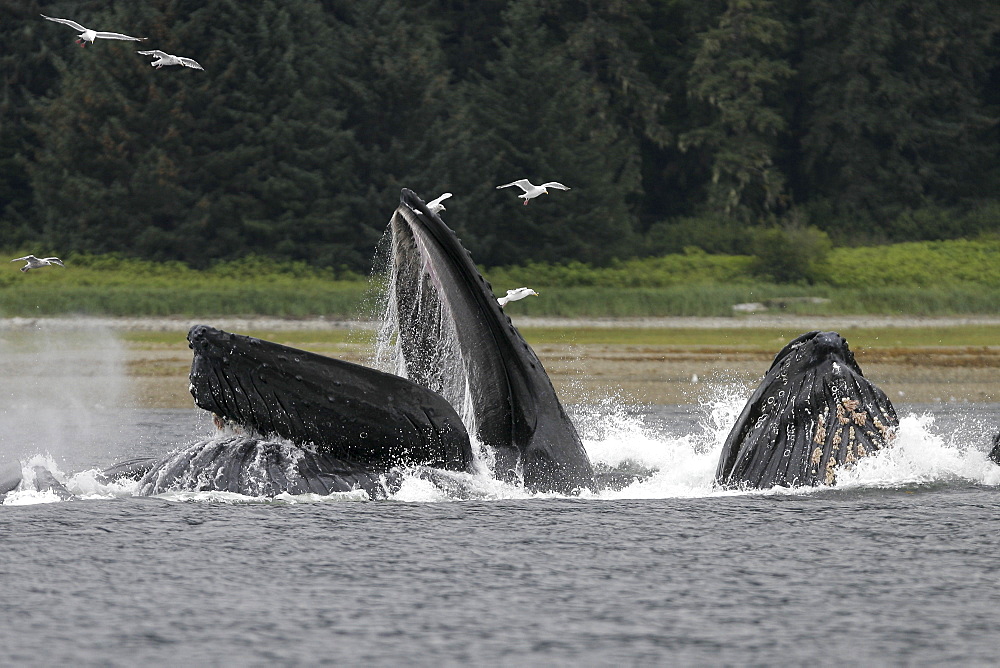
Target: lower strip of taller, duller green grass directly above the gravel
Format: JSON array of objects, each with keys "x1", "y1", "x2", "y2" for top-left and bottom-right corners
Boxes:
[{"x1": 0, "y1": 282, "x2": 1000, "y2": 319}]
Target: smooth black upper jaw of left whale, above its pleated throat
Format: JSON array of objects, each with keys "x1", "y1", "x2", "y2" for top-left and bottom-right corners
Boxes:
[{"x1": 188, "y1": 325, "x2": 472, "y2": 471}]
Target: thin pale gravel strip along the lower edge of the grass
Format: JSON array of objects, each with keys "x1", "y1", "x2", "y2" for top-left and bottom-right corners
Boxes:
[{"x1": 0, "y1": 315, "x2": 1000, "y2": 332}]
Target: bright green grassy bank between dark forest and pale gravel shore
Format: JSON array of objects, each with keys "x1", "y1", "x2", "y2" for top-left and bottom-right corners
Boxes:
[{"x1": 0, "y1": 239, "x2": 1000, "y2": 319}]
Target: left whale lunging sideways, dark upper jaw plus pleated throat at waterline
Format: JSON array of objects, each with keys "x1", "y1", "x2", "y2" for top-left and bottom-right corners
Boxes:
[{"x1": 126, "y1": 325, "x2": 473, "y2": 498}]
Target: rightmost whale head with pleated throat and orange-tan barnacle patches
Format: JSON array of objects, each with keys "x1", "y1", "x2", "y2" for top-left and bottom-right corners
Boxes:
[{"x1": 716, "y1": 331, "x2": 899, "y2": 489}]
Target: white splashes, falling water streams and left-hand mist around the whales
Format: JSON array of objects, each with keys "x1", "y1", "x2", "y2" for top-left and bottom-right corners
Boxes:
[{"x1": 0, "y1": 320, "x2": 1000, "y2": 505}]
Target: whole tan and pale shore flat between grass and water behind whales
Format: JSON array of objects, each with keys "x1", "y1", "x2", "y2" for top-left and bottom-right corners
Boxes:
[{"x1": 0, "y1": 316, "x2": 1000, "y2": 408}]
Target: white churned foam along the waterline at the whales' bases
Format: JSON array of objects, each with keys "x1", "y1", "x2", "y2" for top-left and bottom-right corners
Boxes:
[{"x1": 3, "y1": 396, "x2": 1000, "y2": 506}]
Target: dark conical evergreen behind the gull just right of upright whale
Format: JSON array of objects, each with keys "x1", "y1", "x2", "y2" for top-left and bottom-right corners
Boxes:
[{"x1": 441, "y1": 0, "x2": 639, "y2": 265}]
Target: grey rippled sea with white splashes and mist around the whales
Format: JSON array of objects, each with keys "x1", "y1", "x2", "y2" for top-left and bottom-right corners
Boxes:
[{"x1": 0, "y1": 336, "x2": 1000, "y2": 666}]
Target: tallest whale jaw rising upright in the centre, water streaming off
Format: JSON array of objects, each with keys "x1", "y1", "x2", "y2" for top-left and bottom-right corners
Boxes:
[{"x1": 387, "y1": 188, "x2": 594, "y2": 493}]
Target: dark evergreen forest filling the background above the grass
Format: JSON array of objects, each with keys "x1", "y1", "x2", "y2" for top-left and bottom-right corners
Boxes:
[{"x1": 0, "y1": 0, "x2": 1000, "y2": 271}]
